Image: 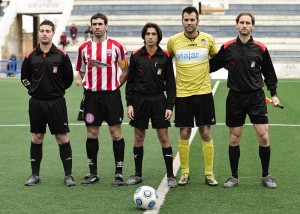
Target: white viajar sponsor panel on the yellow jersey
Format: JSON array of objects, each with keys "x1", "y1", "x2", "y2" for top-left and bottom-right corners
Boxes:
[{"x1": 176, "y1": 48, "x2": 208, "y2": 64}]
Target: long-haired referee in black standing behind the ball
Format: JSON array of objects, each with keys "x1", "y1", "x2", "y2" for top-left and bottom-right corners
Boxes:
[{"x1": 126, "y1": 23, "x2": 177, "y2": 188}]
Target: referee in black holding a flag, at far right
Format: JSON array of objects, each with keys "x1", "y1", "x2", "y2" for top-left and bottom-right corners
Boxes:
[{"x1": 210, "y1": 13, "x2": 279, "y2": 188}]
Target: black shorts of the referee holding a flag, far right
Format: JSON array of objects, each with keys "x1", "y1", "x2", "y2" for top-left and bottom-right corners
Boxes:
[{"x1": 226, "y1": 89, "x2": 269, "y2": 127}]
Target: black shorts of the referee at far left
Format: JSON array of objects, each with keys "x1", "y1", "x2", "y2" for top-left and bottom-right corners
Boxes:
[{"x1": 29, "y1": 97, "x2": 70, "y2": 134}]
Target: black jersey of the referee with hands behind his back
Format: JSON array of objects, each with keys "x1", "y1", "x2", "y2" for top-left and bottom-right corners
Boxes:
[{"x1": 21, "y1": 44, "x2": 73, "y2": 100}]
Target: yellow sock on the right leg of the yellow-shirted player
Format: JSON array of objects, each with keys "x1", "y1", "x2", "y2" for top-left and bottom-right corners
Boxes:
[{"x1": 202, "y1": 140, "x2": 215, "y2": 175}]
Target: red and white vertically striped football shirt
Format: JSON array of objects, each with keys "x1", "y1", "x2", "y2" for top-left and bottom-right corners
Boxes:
[{"x1": 76, "y1": 37, "x2": 127, "y2": 91}]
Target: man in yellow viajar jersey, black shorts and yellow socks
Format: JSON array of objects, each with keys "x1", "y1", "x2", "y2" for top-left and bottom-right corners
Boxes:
[{"x1": 168, "y1": 7, "x2": 218, "y2": 186}]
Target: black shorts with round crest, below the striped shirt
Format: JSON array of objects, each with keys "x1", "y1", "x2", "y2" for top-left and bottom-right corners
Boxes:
[{"x1": 84, "y1": 89, "x2": 124, "y2": 126}]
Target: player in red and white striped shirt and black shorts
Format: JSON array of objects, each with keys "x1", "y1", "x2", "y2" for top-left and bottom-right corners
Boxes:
[{"x1": 76, "y1": 13, "x2": 128, "y2": 186}]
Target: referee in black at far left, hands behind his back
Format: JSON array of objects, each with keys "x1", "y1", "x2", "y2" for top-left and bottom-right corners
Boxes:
[{"x1": 21, "y1": 20, "x2": 75, "y2": 186}]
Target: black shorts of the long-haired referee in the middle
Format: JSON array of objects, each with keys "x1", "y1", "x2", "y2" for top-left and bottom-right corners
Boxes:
[{"x1": 130, "y1": 94, "x2": 171, "y2": 129}]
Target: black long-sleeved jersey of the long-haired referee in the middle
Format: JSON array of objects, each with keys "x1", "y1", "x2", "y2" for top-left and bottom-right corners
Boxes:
[{"x1": 126, "y1": 46, "x2": 176, "y2": 110}]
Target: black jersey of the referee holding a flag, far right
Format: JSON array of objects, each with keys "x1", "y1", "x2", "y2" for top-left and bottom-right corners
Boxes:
[{"x1": 210, "y1": 36, "x2": 278, "y2": 96}]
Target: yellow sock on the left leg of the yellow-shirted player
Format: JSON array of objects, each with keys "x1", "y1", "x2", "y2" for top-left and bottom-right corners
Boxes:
[{"x1": 178, "y1": 138, "x2": 190, "y2": 174}]
